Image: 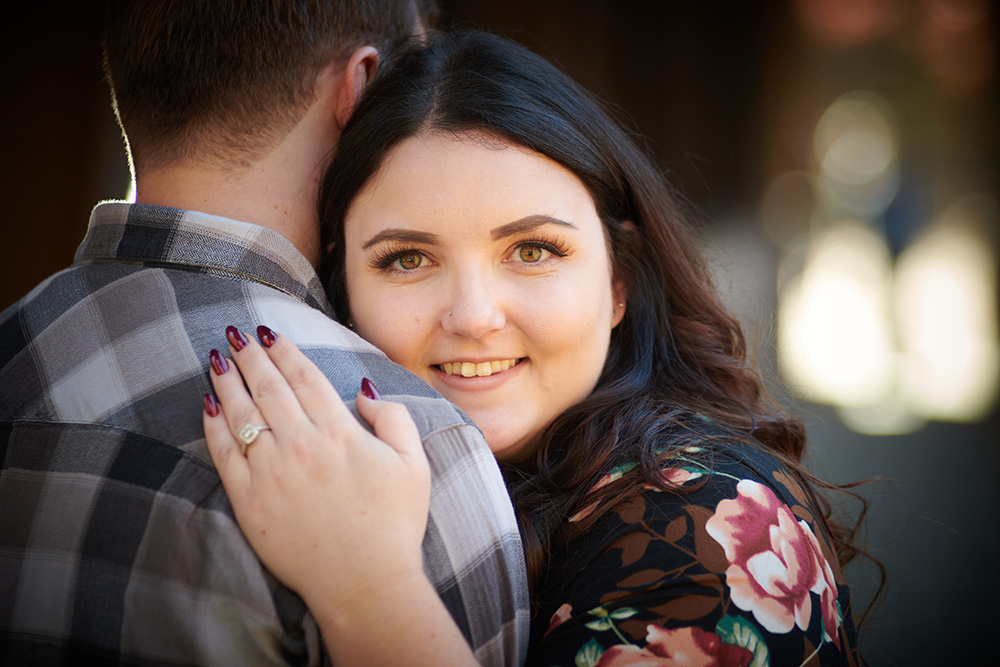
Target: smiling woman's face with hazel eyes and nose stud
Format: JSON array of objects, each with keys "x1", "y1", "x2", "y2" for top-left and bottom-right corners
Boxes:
[{"x1": 344, "y1": 133, "x2": 623, "y2": 461}]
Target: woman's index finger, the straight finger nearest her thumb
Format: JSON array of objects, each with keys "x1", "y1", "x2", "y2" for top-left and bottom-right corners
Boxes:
[{"x1": 258, "y1": 326, "x2": 354, "y2": 425}]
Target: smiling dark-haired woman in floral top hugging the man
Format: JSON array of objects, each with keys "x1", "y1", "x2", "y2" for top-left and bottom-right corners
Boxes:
[{"x1": 205, "y1": 33, "x2": 858, "y2": 665}]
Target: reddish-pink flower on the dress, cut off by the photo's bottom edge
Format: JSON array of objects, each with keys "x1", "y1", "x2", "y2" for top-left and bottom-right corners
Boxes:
[{"x1": 597, "y1": 625, "x2": 753, "y2": 667}]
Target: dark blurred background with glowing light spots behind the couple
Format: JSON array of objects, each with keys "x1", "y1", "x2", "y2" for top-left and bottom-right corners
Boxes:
[{"x1": 0, "y1": 0, "x2": 1000, "y2": 665}]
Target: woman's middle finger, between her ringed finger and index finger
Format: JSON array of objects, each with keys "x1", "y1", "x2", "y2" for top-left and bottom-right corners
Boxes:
[{"x1": 225, "y1": 330, "x2": 307, "y2": 432}]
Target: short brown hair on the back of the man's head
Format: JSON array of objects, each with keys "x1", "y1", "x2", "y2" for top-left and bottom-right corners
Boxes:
[{"x1": 104, "y1": 0, "x2": 434, "y2": 173}]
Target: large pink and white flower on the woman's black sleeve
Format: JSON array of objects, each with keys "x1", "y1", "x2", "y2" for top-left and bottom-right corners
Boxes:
[{"x1": 705, "y1": 479, "x2": 840, "y2": 647}]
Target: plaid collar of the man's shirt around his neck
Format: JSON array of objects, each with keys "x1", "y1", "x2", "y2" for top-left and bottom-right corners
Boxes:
[{"x1": 75, "y1": 202, "x2": 333, "y2": 317}]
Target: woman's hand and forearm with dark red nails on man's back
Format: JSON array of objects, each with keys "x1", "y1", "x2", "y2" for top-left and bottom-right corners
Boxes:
[{"x1": 204, "y1": 336, "x2": 475, "y2": 665}]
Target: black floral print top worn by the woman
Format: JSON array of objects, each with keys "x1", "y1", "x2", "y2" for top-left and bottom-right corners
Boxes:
[{"x1": 527, "y1": 442, "x2": 860, "y2": 667}]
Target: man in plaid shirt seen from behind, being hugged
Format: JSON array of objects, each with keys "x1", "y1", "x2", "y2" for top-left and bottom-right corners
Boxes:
[{"x1": 0, "y1": 0, "x2": 527, "y2": 665}]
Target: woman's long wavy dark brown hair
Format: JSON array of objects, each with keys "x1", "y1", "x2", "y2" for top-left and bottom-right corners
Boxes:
[{"x1": 320, "y1": 32, "x2": 876, "y2": 612}]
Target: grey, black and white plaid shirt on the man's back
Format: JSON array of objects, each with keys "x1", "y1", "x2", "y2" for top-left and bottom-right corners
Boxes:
[{"x1": 0, "y1": 203, "x2": 528, "y2": 665}]
